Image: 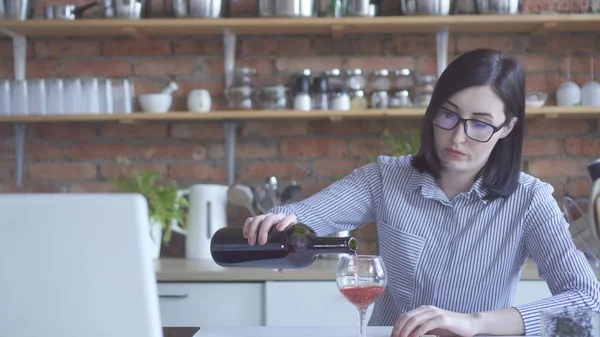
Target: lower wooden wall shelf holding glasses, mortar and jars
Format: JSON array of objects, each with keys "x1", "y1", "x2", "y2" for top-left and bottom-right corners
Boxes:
[{"x1": 0, "y1": 106, "x2": 600, "y2": 123}]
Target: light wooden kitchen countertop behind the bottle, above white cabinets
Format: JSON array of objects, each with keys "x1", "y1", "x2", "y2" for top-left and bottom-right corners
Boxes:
[{"x1": 155, "y1": 258, "x2": 552, "y2": 282}]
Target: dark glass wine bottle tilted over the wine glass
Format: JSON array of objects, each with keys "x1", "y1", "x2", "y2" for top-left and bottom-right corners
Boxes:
[{"x1": 210, "y1": 223, "x2": 358, "y2": 269}]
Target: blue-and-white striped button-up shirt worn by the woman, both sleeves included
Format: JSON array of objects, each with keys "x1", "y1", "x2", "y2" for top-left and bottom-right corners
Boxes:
[{"x1": 270, "y1": 156, "x2": 600, "y2": 335}]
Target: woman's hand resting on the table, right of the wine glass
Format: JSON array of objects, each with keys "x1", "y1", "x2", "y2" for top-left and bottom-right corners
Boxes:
[{"x1": 391, "y1": 305, "x2": 477, "y2": 337}]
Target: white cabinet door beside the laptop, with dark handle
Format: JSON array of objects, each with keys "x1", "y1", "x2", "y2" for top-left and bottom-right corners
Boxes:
[{"x1": 158, "y1": 282, "x2": 264, "y2": 327}]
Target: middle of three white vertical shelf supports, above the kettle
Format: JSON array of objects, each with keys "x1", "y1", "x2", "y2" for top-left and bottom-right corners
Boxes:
[{"x1": 223, "y1": 29, "x2": 237, "y2": 186}]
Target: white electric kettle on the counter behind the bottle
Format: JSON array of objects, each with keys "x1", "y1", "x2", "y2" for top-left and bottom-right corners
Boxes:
[{"x1": 171, "y1": 184, "x2": 229, "y2": 261}]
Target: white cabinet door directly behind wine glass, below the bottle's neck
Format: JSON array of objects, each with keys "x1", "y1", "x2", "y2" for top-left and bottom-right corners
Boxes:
[{"x1": 265, "y1": 281, "x2": 373, "y2": 326}]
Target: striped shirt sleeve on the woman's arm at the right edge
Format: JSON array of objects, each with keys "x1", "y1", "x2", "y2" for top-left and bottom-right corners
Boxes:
[{"x1": 515, "y1": 183, "x2": 600, "y2": 336}]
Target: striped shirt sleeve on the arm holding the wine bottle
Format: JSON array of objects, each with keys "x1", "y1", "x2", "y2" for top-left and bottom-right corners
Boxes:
[{"x1": 267, "y1": 159, "x2": 382, "y2": 236}]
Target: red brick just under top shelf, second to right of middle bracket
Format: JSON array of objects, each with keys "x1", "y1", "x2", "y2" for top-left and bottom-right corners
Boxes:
[{"x1": 313, "y1": 37, "x2": 382, "y2": 55}]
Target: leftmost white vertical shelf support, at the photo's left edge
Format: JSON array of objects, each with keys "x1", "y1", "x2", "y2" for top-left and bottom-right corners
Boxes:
[{"x1": 0, "y1": 28, "x2": 27, "y2": 187}]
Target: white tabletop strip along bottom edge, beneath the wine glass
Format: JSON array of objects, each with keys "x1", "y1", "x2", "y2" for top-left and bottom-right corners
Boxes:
[{"x1": 194, "y1": 326, "x2": 523, "y2": 337}]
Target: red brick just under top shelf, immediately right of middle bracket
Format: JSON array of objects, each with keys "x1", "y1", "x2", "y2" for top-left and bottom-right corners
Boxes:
[{"x1": 241, "y1": 37, "x2": 311, "y2": 56}]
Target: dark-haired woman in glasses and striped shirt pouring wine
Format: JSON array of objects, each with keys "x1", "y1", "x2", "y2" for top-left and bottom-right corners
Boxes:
[{"x1": 244, "y1": 49, "x2": 600, "y2": 337}]
